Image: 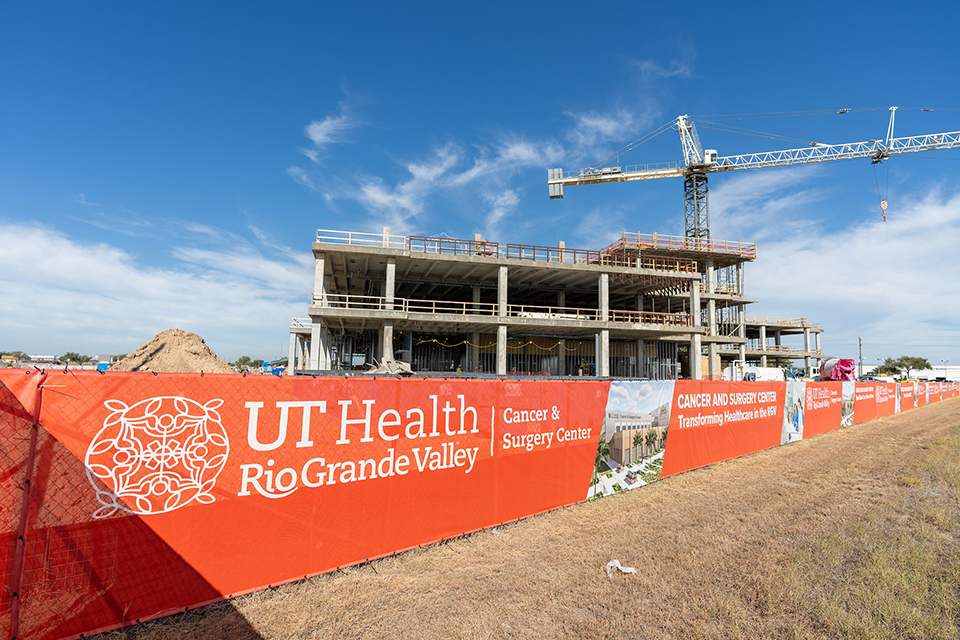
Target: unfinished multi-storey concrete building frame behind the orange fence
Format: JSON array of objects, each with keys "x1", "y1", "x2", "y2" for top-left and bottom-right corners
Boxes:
[{"x1": 289, "y1": 227, "x2": 821, "y2": 380}]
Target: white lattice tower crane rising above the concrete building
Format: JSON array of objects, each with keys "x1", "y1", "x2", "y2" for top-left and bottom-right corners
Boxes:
[{"x1": 547, "y1": 107, "x2": 960, "y2": 240}]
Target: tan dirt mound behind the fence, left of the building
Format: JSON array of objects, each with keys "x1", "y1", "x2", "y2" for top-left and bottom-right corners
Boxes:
[{"x1": 111, "y1": 329, "x2": 236, "y2": 373}]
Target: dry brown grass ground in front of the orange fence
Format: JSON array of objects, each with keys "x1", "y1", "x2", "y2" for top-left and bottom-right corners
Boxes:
[{"x1": 99, "y1": 399, "x2": 960, "y2": 640}]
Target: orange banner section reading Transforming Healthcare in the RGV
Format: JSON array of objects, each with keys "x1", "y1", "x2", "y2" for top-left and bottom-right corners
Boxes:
[{"x1": 661, "y1": 380, "x2": 786, "y2": 478}]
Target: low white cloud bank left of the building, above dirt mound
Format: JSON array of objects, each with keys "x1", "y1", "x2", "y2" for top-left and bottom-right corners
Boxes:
[{"x1": 0, "y1": 220, "x2": 312, "y2": 360}]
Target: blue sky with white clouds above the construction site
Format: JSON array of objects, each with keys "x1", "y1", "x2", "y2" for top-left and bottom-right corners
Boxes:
[{"x1": 0, "y1": 2, "x2": 960, "y2": 365}]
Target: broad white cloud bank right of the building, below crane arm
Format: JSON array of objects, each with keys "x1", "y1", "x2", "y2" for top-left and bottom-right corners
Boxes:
[{"x1": 715, "y1": 177, "x2": 960, "y2": 361}]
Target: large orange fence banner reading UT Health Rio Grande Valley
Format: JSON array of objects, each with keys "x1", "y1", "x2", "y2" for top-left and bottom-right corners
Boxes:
[{"x1": 0, "y1": 371, "x2": 609, "y2": 638}]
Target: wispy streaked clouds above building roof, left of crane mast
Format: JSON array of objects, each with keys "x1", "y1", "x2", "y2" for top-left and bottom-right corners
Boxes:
[{"x1": 287, "y1": 53, "x2": 690, "y2": 237}]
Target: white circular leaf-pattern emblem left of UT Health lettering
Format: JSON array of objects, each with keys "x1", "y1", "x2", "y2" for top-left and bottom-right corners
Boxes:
[{"x1": 84, "y1": 396, "x2": 230, "y2": 518}]
